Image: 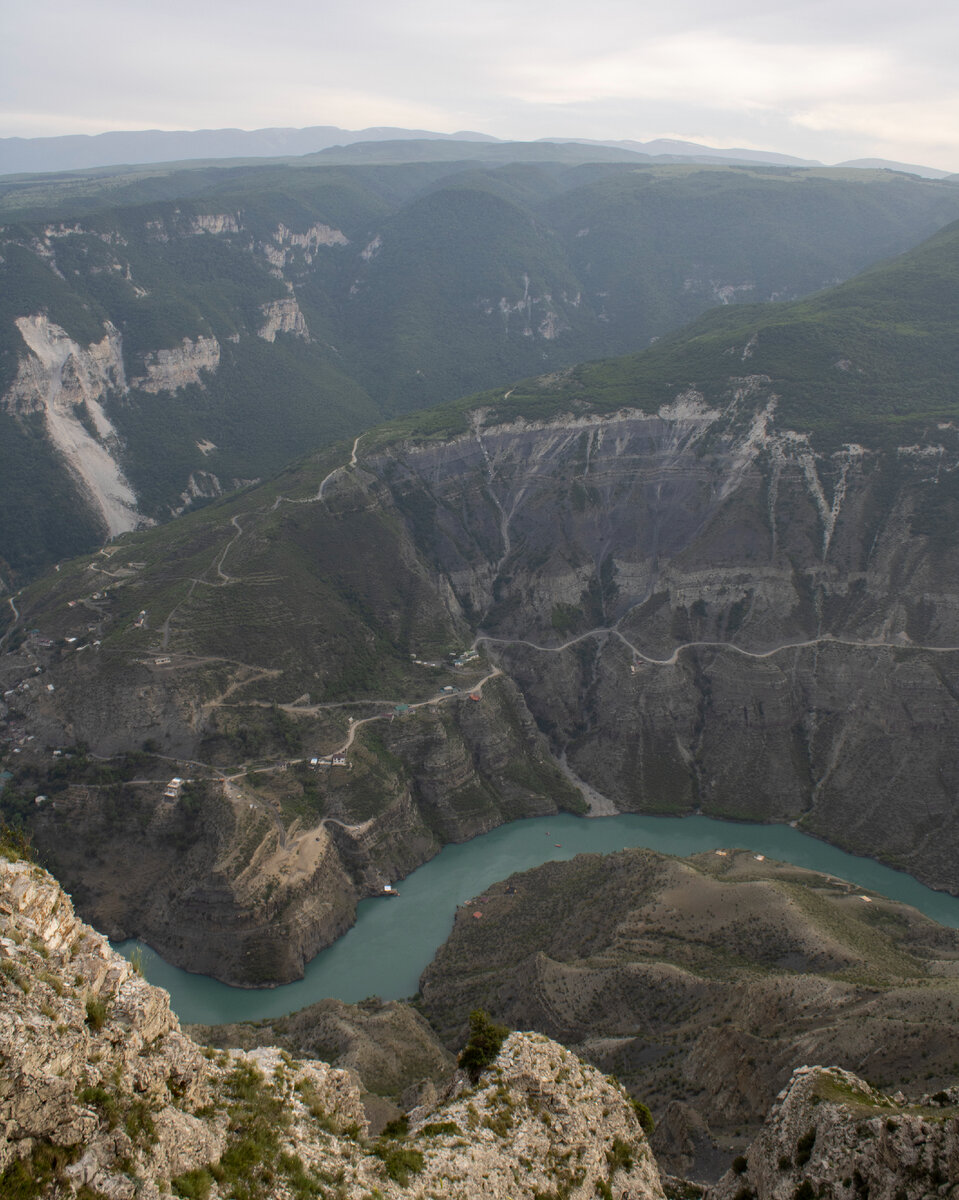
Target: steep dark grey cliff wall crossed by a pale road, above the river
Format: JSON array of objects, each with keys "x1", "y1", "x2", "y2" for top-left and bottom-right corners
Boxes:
[{"x1": 367, "y1": 403, "x2": 959, "y2": 888}]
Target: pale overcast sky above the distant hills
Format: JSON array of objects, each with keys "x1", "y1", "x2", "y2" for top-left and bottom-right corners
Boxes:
[{"x1": 0, "y1": 0, "x2": 959, "y2": 172}]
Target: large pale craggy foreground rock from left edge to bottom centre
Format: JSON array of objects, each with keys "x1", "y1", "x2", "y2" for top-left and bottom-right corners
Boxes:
[{"x1": 0, "y1": 859, "x2": 663, "y2": 1200}]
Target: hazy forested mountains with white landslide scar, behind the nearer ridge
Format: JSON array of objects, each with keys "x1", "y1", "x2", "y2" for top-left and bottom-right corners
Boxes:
[{"x1": 0, "y1": 151, "x2": 959, "y2": 587}]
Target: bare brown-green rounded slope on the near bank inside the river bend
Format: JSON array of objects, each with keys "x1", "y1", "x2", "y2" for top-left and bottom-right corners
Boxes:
[{"x1": 421, "y1": 850, "x2": 959, "y2": 1156}]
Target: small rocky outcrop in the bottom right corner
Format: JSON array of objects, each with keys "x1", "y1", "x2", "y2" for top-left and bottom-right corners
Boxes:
[{"x1": 707, "y1": 1067, "x2": 959, "y2": 1200}]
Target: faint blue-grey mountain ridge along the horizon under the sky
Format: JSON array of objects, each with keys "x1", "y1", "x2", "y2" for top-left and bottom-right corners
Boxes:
[{"x1": 0, "y1": 125, "x2": 948, "y2": 179}]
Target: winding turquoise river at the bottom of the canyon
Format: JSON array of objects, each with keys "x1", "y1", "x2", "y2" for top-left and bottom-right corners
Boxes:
[{"x1": 116, "y1": 815, "x2": 959, "y2": 1024}]
